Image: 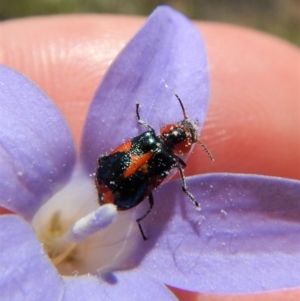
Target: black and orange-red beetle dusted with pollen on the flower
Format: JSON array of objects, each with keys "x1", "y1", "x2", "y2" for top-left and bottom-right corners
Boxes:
[{"x1": 95, "y1": 94, "x2": 213, "y2": 240}]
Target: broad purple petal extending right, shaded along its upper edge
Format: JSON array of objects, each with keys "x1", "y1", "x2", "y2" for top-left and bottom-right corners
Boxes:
[{"x1": 140, "y1": 174, "x2": 300, "y2": 293}]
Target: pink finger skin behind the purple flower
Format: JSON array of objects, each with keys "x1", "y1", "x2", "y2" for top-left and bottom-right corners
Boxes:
[{"x1": 0, "y1": 15, "x2": 300, "y2": 301}]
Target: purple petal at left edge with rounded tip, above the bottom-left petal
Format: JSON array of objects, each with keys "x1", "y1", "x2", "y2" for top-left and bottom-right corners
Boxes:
[{"x1": 0, "y1": 66, "x2": 75, "y2": 219}]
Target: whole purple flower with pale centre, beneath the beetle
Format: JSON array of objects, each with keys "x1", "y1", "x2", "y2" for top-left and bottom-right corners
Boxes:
[{"x1": 0, "y1": 7, "x2": 300, "y2": 301}]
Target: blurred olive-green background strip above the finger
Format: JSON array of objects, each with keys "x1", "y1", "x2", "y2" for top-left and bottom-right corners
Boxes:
[{"x1": 0, "y1": 0, "x2": 300, "y2": 45}]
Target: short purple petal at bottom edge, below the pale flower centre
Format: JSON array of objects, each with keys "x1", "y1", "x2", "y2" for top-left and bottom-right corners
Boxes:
[{"x1": 63, "y1": 270, "x2": 177, "y2": 301}]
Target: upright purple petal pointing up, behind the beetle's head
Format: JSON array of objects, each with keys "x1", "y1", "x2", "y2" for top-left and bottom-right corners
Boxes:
[{"x1": 81, "y1": 6, "x2": 209, "y2": 173}]
